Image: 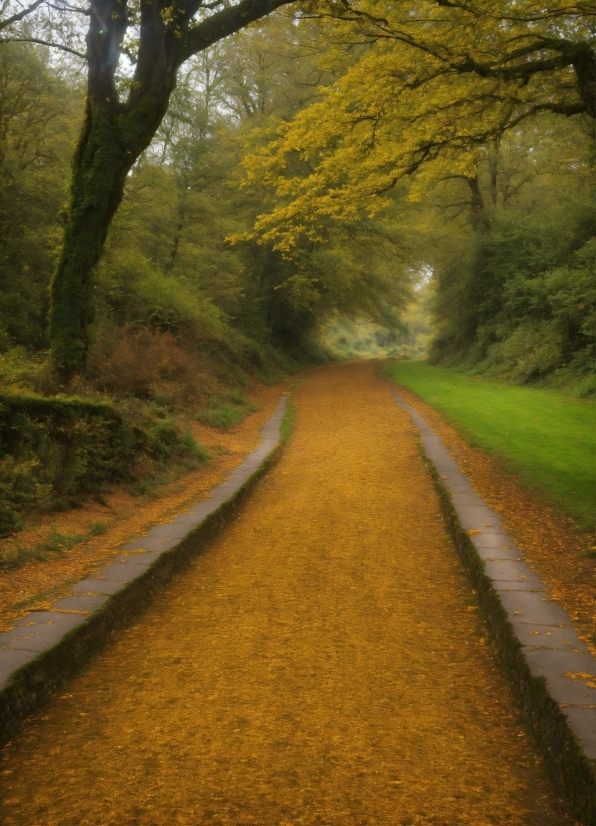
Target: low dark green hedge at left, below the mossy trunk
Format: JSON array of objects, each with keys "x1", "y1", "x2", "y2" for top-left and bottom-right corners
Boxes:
[{"x1": 0, "y1": 392, "x2": 208, "y2": 536}]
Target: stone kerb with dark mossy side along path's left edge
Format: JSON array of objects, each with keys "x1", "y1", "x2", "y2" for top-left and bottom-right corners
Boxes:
[{"x1": 0, "y1": 393, "x2": 288, "y2": 742}]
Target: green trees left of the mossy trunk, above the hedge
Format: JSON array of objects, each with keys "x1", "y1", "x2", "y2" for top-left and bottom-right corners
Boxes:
[{"x1": 0, "y1": 43, "x2": 82, "y2": 351}]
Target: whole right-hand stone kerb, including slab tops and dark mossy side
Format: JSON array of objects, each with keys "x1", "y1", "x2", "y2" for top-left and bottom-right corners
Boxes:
[{"x1": 393, "y1": 393, "x2": 596, "y2": 826}]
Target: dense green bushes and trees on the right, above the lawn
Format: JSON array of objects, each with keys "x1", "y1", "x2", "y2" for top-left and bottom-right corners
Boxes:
[{"x1": 430, "y1": 118, "x2": 596, "y2": 395}]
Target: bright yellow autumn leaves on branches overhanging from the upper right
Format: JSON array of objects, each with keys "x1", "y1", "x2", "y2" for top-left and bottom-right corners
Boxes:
[{"x1": 243, "y1": 0, "x2": 592, "y2": 252}]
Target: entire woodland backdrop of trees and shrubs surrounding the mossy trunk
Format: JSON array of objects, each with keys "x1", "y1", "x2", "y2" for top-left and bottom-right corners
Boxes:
[{"x1": 0, "y1": 2, "x2": 596, "y2": 534}]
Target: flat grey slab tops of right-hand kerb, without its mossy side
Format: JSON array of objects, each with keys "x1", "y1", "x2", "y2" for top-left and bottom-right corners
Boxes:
[{"x1": 394, "y1": 393, "x2": 596, "y2": 759}]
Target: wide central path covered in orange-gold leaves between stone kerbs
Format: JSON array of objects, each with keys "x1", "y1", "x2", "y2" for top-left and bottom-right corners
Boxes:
[{"x1": 0, "y1": 363, "x2": 567, "y2": 826}]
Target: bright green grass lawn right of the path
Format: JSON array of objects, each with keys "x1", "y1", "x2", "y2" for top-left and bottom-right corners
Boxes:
[{"x1": 389, "y1": 361, "x2": 596, "y2": 530}]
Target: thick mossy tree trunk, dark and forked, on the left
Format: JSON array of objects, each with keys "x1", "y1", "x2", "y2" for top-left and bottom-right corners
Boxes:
[{"x1": 50, "y1": 0, "x2": 292, "y2": 383}]
